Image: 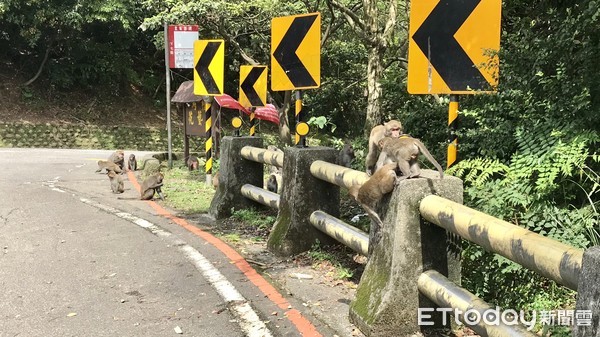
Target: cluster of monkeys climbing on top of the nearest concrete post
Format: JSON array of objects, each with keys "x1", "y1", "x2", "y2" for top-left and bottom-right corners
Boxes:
[{"x1": 349, "y1": 120, "x2": 444, "y2": 226}]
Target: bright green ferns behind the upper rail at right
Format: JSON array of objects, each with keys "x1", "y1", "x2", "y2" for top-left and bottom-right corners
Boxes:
[{"x1": 448, "y1": 123, "x2": 600, "y2": 246}]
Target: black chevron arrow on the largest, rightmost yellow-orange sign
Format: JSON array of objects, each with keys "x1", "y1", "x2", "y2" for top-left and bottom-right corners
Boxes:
[{"x1": 413, "y1": 0, "x2": 489, "y2": 91}]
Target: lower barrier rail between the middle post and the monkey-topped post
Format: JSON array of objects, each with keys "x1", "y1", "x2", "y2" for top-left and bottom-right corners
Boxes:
[{"x1": 310, "y1": 211, "x2": 369, "y2": 256}]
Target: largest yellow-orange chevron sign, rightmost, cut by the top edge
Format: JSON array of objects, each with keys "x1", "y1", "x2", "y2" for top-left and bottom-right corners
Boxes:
[{"x1": 408, "y1": 0, "x2": 502, "y2": 94}]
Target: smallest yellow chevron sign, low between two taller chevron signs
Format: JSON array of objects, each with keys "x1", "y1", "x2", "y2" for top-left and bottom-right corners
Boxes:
[{"x1": 239, "y1": 66, "x2": 267, "y2": 108}]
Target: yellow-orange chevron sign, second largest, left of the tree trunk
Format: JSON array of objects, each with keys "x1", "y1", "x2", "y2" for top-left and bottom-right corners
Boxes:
[{"x1": 271, "y1": 13, "x2": 321, "y2": 91}]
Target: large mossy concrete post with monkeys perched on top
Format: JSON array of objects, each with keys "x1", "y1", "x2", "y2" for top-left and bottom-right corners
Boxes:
[{"x1": 350, "y1": 170, "x2": 463, "y2": 337}]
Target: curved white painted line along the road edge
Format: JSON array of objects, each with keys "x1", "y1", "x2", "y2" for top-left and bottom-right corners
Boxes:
[{"x1": 79, "y1": 198, "x2": 273, "y2": 337}]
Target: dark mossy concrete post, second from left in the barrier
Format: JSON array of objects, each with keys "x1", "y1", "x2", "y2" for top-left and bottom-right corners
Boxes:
[{"x1": 267, "y1": 147, "x2": 340, "y2": 256}]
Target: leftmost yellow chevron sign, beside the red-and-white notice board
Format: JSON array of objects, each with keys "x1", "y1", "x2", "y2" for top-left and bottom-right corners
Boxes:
[{"x1": 194, "y1": 40, "x2": 225, "y2": 96}]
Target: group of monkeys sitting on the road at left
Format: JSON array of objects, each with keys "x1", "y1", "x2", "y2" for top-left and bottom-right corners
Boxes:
[{"x1": 96, "y1": 150, "x2": 164, "y2": 200}]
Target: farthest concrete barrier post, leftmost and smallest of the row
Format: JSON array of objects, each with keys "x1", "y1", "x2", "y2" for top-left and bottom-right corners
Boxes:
[{"x1": 209, "y1": 137, "x2": 263, "y2": 219}]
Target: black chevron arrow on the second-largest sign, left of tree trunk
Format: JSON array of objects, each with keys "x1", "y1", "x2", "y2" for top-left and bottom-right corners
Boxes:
[{"x1": 273, "y1": 15, "x2": 317, "y2": 87}]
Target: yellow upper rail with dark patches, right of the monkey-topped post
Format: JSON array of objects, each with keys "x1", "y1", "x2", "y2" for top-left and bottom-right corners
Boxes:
[{"x1": 420, "y1": 195, "x2": 583, "y2": 290}]
